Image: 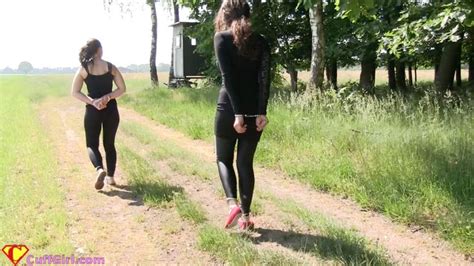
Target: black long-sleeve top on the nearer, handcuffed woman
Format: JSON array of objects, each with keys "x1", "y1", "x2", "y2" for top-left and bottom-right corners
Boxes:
[{"x1": 214, "y1": 31, "x2": 270, "y2": 115}]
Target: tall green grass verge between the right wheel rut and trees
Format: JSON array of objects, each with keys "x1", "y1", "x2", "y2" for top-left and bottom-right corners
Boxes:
[{"x1": 123, "y1": 82, "x2": 474, "y2": 253}]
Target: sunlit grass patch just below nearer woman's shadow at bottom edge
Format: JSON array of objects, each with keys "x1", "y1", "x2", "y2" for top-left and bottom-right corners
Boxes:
[{"x1": 198, "y1": 225, "x2": 301, "y2": 265}]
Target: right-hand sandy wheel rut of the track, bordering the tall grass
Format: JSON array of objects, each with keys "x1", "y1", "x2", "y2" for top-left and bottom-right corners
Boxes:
[{"x1": 120, "y1": 105, "x2": 469, "y2": 265}]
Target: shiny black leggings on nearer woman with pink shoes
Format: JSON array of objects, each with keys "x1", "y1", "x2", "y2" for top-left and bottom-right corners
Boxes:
[{"x1": 216, "y1": 136, "x2": 258, "y2": 214}]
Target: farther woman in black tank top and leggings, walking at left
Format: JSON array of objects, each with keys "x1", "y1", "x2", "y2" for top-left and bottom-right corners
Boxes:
[{"x1": 71, "y1": 39, "x2": 126, "y2": 190}]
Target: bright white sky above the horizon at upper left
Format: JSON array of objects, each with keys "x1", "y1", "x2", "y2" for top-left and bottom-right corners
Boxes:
[{"x1": 0, "y1": 0, "x2": 189, "y2": 69}]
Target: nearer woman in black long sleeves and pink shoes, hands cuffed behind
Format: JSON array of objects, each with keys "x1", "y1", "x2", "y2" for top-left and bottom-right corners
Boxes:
[{"x1": 214, "y1": 0, "x2": 270, "y2": 230}]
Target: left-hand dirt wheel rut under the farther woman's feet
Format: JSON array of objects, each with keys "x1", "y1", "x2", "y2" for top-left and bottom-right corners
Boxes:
[{"x1": 38, "y1": 99, "x2": 216, "y2": 265}]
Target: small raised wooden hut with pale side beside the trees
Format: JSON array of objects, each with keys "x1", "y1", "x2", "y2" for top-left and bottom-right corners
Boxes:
[{"x1": 170, "y1": 21, "x2": 205, "y2": 86}]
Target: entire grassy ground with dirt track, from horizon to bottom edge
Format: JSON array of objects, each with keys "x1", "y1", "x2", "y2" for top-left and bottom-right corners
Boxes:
[{"x1": 0, "y1": 72, "x2": 474, "y2": 265}]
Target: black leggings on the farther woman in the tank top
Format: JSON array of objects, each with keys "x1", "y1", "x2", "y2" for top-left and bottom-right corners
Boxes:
[{"x1": 84, "y1": 105, "x2": 120, "y2": 176}]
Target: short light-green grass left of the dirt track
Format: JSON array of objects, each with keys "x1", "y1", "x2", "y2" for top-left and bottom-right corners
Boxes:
[{"x1": 0, "y1": 76, "x2": 73, "y2": 258}]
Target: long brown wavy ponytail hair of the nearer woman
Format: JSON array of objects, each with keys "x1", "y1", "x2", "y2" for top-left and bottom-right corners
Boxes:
[{"x1": 214, "y1": 0, "x2": 254, "y2": 57}]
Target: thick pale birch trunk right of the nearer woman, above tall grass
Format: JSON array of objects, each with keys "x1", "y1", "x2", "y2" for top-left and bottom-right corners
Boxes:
[{"x1": 308, "y1": 0, "x2": 325, "y2": 89}]
